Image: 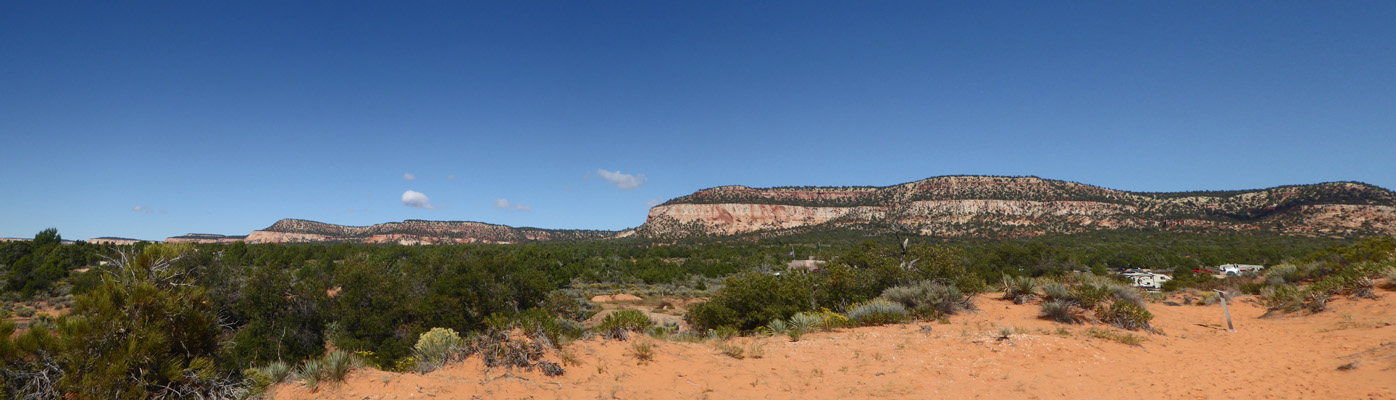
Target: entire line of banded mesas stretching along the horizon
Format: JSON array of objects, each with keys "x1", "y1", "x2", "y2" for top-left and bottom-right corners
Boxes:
[{"x1": 94, "y1": 176, "x2": 1396, "y2": 244}]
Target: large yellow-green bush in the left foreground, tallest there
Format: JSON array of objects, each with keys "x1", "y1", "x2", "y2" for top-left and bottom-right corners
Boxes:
[{"x1": 59, "y1": 245, "x2": 225, "y2": 399}]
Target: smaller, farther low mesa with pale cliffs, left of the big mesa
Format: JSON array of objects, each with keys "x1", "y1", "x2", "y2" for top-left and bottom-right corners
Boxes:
[{"x1": 246, "y1": 219, "x2": 616, "y2": 244}]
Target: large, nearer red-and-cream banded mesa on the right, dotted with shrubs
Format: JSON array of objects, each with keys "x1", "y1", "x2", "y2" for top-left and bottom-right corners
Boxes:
[{"x1": 637, "y1": 176, "x2": 1396, "y2": 237}]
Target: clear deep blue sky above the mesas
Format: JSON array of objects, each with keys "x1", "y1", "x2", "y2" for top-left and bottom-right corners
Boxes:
[{"x1": 0, "y1": 1, "x2": 1396, "y2": 240}]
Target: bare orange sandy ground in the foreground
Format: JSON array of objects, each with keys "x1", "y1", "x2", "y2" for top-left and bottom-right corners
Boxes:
[{"x1": 272, "y1": 290, "x2": 1396, "y2": 400}]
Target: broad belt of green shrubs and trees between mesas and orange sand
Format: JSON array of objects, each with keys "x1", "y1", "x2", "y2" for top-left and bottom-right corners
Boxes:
[{"x1": 0, "y1": 231, "x2": 1396, "y2": 399}]
